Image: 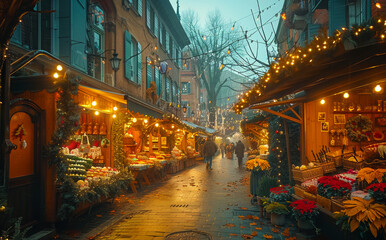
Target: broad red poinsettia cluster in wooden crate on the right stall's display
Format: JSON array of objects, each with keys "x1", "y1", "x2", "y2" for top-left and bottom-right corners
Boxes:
[{"x1": 317, "y1": 176, "x2": 352, "y2": 198}]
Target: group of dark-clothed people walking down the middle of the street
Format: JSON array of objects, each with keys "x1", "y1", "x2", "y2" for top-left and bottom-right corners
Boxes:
[{"x1": 202, "y1": 137, "x2": 245, "y2": 169}]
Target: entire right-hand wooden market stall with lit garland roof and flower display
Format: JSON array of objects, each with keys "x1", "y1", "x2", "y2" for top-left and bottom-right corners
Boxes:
[{"x1": 234, "y1": 15, "x2": 386, "y2": 239}]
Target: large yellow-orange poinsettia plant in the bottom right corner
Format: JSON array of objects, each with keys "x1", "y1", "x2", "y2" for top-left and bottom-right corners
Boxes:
[{"x1": 334, "y1": 197, "x2": 386, "y2": 239}]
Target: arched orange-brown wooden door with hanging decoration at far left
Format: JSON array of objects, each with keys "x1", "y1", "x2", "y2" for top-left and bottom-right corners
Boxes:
[{"x1": 8, "y1": 101, "x2": 44, "y2": 225}]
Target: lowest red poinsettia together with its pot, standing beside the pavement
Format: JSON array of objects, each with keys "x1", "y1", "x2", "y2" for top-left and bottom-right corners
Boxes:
[{"x1": 290, "y1": 199, "x2": 320, "y2": 233}]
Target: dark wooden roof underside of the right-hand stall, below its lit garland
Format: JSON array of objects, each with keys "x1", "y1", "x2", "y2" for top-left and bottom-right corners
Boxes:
[{"x1": 252, "y1": 42, "x2": 386, "y2": 108}]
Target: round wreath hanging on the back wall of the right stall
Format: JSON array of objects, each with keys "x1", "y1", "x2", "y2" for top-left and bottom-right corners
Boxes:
[{"x1": 346, "y1": 115, "x2": 373, "y2": 142}]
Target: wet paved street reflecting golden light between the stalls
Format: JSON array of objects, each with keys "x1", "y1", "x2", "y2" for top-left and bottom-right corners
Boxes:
[{"x1": 59, "y1": 156, "x2": 295, "y2": 240}]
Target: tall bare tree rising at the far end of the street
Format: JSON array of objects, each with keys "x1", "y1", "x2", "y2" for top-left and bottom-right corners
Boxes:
[{"x1": 183, "y1": 11, "x2": 243, "y2": 124}]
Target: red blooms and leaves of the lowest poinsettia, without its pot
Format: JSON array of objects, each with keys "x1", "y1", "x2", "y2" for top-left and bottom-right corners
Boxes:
[{"x1": 290, "y1": 199, "x2": 319, "y2": 222}]
